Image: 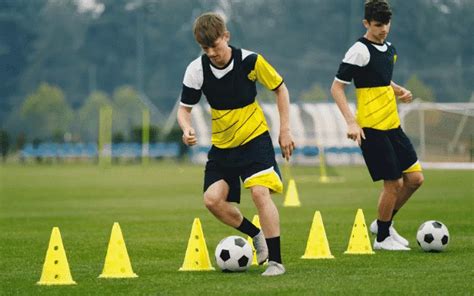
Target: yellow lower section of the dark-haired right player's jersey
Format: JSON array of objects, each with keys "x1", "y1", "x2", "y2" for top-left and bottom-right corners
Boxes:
[{"x1": 356, "y1": 85, "x2": 400, "y2": 130}]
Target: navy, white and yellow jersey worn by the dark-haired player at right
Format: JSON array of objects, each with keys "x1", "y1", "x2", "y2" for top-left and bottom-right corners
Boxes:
[{"x1": 336, "y1": 38, "x2": 400, "y2": 130}]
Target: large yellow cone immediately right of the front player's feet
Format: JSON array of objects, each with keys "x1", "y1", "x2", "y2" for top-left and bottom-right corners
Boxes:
[{"x1": 301, "y1": 211, "x2": 334, "y2": 259}]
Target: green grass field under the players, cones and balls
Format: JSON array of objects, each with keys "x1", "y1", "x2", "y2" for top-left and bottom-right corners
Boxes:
[{"x1": 0, "y1": 163, "x2": 474, "y2": 295}]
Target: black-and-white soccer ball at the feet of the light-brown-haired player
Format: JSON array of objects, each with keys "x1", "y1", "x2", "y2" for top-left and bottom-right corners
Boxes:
[{"x1": 215, "y1": 235, "x2": 253, "y2": 271}]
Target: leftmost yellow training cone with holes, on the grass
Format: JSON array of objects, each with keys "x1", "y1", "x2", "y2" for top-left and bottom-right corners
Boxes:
[{"x1": 37, "y1": 227, "x2": 76, "y2": 285}]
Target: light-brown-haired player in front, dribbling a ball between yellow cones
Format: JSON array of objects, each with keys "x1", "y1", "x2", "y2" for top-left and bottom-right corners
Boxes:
[{"x1": 178, "y1": 13, "x2": 295, "y2": 276}]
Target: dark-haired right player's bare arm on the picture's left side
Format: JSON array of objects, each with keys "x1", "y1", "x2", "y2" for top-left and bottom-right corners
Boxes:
[{"x1": 331, "y1": 79, "x2": 365, "y2": 146}]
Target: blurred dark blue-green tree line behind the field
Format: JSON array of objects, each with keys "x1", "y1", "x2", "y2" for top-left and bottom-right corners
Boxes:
[{"x1": 0, "y1": 0, "x2": 474, "y2": 150}]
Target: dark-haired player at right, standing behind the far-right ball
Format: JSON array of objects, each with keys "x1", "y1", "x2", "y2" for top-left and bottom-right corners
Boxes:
[{"x1": 331, "y1": 0, "x2": 423, "y2": 251}]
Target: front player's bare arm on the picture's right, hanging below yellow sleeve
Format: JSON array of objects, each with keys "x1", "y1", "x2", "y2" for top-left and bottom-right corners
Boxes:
[{"x1": 274, "y1": 83, "x2": 295, "y2": 160}]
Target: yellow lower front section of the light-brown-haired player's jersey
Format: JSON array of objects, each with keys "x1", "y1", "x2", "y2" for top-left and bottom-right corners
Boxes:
[{"x1": 211, "y1": 101, "x2": 268, "y2": 149}]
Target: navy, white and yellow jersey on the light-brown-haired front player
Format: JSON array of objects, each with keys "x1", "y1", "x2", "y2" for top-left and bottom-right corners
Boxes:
[{"x1": 181, "y1": 47, "x2": 283, "y2": 149}]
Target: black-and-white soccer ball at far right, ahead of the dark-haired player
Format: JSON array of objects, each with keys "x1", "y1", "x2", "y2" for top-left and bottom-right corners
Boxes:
[{"x1": 416, "y1": 220, "x2": 450, "y2": 252}]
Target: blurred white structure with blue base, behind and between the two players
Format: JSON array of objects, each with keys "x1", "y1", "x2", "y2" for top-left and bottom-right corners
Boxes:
[{"x1": 191, "y1": 103, "x2": 363, "y2": 164}]
